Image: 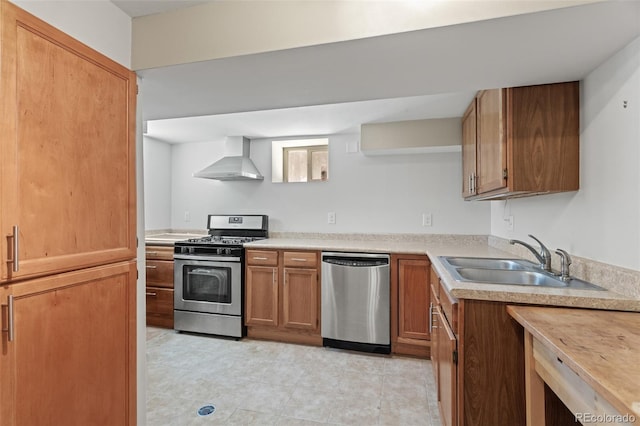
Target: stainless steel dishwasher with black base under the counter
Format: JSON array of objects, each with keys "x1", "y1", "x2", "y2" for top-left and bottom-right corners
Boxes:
[{"x1": 321, "y1": 252, "x2": 391, "y2": 354}]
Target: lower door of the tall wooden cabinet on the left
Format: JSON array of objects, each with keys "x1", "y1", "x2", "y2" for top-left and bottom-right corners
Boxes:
[{"x1": 0, "y1": 262, "x2": 136, "y2": 426}]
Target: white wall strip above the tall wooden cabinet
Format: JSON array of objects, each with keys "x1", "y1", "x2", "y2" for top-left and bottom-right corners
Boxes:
[{"x1": 11, "y1": 0, "x2": 132, "y2": 68}]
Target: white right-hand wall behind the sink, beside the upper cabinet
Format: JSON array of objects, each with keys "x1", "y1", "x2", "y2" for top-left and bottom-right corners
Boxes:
[{"x1": 491, "y1": 38, "x2": 640, "y2": 270}]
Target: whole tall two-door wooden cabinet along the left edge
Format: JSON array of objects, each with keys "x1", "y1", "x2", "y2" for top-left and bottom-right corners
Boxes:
[{"x1": 0, "y1": 0, "x2": 136, "y2": 426}]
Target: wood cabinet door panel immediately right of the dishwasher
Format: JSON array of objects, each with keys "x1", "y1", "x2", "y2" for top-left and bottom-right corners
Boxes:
[{"x1": 398, "y1": 259, "x2": 430, "y2": 340}]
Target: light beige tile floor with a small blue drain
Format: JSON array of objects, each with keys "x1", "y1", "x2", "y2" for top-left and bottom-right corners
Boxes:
[{"x1": 147, "y1": 327, "x2": 440, "y2": 426}]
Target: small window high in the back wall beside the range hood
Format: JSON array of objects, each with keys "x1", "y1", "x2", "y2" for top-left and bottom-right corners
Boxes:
[{"x1": 271, "y1": 138, "x2": 329, "y2": 183}]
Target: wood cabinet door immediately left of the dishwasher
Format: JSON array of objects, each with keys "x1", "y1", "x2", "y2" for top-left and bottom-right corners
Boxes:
[{"x1": 282, "y1": 268, "x2": 319, "y2": 330}]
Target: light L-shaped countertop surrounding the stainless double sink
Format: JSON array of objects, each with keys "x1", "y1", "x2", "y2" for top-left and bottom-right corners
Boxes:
[{"x1": 245, "y1": 236, "x2": 640, "y2": 312}]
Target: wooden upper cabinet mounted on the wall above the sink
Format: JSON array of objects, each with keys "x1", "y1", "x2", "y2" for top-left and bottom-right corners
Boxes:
[{"x1": 463, "y1": 81, "x2": 580, "y2": 199}]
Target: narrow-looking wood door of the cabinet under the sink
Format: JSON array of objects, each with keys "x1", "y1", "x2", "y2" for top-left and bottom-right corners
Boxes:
[{"x1": 436, "y1": 308, "x2": 458, "y2": 426}]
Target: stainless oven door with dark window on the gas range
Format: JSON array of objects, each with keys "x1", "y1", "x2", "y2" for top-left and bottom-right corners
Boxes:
[{"x1": 174, "y1": 257, "x2": 242, "y2": 315}]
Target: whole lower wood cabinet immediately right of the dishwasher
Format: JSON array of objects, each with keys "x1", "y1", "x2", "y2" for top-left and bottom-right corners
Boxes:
[{"x1": 391, "y1": 254, "x2": 431, "y2": 357}]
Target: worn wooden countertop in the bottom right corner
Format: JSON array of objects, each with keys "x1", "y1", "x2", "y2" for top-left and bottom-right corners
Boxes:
[{"x1": 507, "y1": 306, "x2": 640, "y2": 420}]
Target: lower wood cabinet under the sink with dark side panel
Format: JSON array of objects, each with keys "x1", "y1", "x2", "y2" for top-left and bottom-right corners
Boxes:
[{"x1": 431, "y1": 264, "x2": 526, "y2": 426}]
